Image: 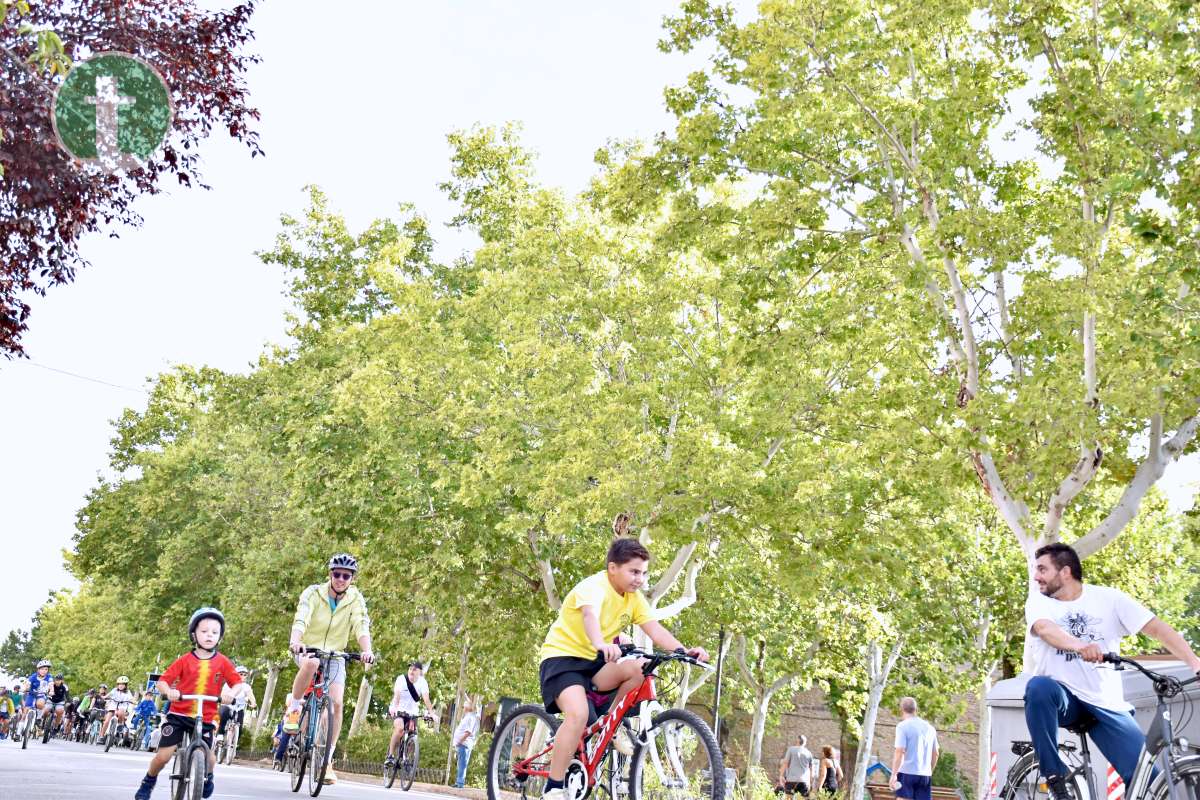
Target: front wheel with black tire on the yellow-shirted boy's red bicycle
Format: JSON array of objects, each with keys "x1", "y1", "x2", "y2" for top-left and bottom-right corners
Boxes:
[{"x1": 629, "y1": 709, "x2": 725, "y2": 800}]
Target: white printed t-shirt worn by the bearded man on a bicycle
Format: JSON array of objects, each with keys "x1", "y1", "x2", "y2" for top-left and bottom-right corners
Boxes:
[{"x1": 1025, "y1": 584, "x2": 1154, "y2": 711}]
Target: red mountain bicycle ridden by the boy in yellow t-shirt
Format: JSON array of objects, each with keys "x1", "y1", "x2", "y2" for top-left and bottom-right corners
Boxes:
[{"x1": 487, "y1": 645, "x2": 725, "y2": 800}]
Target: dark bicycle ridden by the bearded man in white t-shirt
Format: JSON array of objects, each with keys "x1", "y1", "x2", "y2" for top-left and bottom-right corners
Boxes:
[{"x1": 1000, "y1": 652, "x2": 1200, "y2": 800}]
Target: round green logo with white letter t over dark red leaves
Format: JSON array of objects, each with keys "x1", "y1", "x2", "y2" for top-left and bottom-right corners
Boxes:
[{"x1": 53, "y1": 53, "x2": 174, "y2": 172}]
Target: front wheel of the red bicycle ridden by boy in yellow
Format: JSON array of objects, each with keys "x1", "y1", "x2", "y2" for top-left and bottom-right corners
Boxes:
[{"x1": 629, "y1": 709, "x2": 725, "y2": 800}]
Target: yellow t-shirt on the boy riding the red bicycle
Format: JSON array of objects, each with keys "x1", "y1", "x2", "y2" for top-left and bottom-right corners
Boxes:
[{"x1": 540, "y1": 570, "x2": 650, "y2": 661}]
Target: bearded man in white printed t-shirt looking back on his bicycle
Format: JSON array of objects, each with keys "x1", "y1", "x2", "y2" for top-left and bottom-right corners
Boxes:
[{"x1": 1025, "y1": 543, "x2": 1200, "y2": 800}]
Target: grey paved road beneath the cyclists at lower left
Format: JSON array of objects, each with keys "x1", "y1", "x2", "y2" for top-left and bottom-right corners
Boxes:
[{"x1": 0, "y1": 740, "x2": 461, "y2": 800}]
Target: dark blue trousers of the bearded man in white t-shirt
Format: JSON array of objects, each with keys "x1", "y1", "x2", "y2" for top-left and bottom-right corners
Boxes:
[{"x1": 1025, "y1": 675, "x2": 1146, "y2": 786}]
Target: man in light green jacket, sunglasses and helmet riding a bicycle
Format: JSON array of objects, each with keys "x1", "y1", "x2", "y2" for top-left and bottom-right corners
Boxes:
[{"x1": 283, "y1": 553, "x2": 374, "y2": 783}]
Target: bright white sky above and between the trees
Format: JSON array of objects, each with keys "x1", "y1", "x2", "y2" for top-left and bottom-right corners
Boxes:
[{"x1": 0, "y1": 0, "x2": 1200, "y2": 686}]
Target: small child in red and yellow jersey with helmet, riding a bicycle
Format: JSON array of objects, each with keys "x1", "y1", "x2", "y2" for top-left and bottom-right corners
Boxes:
[{"x1": 133, "y1": 607, "x2": 250, "y2": 800}]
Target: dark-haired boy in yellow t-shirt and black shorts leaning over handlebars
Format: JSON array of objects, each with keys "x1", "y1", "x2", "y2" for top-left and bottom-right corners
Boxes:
[{"x1": 539, "y1": 539, "x2": 708, "y2": 800}]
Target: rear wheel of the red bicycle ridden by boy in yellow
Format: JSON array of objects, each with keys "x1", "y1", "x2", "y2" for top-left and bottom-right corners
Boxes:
[{"x1": 487, "y1": 704, "x2": 560, "y2": 800}]
